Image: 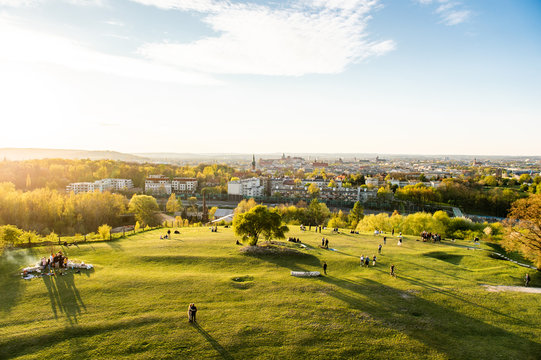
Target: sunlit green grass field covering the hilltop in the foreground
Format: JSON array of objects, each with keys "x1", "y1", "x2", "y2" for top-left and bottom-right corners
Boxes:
[{"x1": 0, "y1": 226, "x2": 541, "y2": 360}]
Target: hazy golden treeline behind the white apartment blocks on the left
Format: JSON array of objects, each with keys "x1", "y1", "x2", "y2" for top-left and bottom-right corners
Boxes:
[{"x1": 0, "y1": 159, "x2": 238, "y2": 192}]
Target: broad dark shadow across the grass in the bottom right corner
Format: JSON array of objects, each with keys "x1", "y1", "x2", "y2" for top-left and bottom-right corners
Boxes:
[{"x1": 320, "y1": 277, "x2": 541, "y2": 359}]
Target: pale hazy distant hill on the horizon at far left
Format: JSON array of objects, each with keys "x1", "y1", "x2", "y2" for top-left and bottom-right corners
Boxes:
[{"x1": 0, "y1": 148, "x2": 149, "y2": 162}]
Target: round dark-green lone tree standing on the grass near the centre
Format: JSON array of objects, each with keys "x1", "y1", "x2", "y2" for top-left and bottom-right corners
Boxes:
[{"x1": 233, "y1": 205, "x2": 289, "y2": 246}]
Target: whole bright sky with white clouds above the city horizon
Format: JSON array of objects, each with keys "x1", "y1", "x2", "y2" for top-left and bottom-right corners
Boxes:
[{"x1": 0, "y1": 0, "x2": 541, "y2": 156}]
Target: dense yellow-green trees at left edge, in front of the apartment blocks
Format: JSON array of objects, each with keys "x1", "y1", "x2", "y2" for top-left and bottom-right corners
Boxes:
[{"x1": 0, "y1": 183, "x2": 128, "y2": 235}]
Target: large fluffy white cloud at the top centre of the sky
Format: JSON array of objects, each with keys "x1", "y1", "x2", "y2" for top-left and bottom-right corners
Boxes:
[{"x1": 134, "y1": 0, "x2": 395, "y2": 76}]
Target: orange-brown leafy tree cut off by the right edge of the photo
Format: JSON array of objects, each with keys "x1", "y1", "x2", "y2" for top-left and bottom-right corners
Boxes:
[{"x1": 503, "y1": 194, "x2": 541, "y2": 270}]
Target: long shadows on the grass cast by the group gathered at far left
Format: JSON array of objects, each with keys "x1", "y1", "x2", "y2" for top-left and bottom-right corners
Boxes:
[{"x1": 42, "y1": 272, "x2": 90, "y2": 325}]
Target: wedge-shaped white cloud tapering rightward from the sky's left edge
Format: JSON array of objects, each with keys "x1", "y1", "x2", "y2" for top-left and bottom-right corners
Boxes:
[{"x1": 0, "y1": 16, "x2": 218, "y2": 85}]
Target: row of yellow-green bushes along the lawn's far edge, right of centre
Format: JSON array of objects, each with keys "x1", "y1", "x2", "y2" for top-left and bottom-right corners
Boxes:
[{"x1": 356, "y1": 211, "x2": 503, "y2": 239}]
